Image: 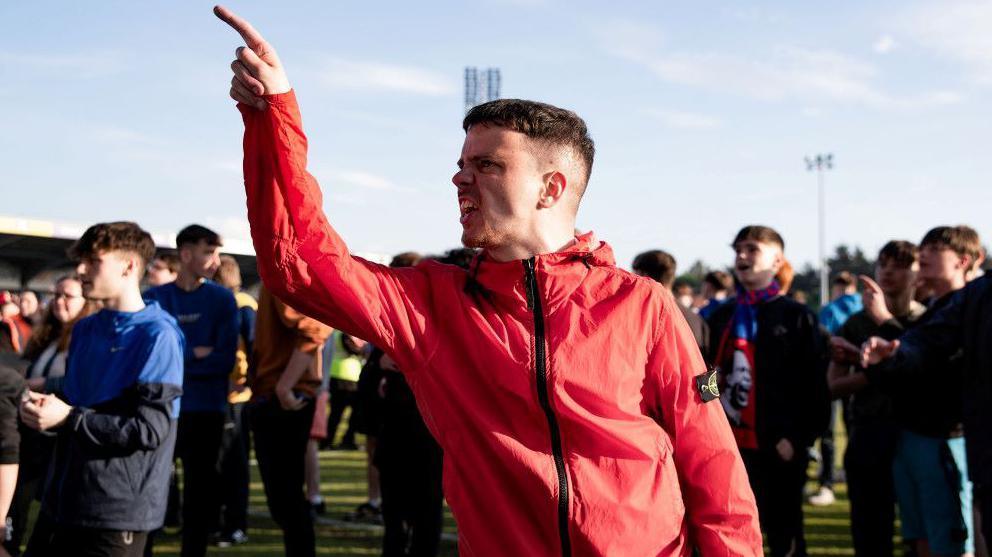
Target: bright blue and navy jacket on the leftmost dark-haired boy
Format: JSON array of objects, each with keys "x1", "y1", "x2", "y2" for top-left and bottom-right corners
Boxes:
[{"x1": 42, "y1": 302, "x2": 183, "y2": 531}]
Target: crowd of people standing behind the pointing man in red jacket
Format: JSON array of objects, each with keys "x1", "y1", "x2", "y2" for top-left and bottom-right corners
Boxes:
[{"x1": 0, "y1": 192, "x2": 987, "y2": 556}]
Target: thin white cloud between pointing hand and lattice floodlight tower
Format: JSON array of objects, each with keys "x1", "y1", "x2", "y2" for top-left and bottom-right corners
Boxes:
[{"x1": 320, "y1": 59, "x2": 458, "y2": 97}]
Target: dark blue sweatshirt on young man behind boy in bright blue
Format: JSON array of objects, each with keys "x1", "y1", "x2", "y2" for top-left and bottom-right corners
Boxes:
[{"x1": 144, "y1": 280, "x2": 239, "y2": 413}]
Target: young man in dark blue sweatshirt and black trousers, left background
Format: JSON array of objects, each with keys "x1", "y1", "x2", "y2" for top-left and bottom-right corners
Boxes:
[{"x1": 145, "y1": 224, "x2": 239, "y2": 557}]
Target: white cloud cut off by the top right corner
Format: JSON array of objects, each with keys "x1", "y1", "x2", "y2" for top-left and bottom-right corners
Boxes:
[{"x1": 899, "y1": 0, "x2": 992, "y2": 84}]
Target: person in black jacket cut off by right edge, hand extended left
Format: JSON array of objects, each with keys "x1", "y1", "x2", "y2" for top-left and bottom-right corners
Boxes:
[{"x1": 861, "y1": 275, "x2": 992, "y2": 542}]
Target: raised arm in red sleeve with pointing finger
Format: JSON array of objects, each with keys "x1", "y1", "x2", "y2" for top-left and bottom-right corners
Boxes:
[{"x1": 214, "y1": 6, "x2": 432, "y2": 369}]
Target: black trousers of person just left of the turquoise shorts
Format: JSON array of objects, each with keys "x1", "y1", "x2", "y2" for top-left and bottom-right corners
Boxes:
[{"x1": 844, "y1": 424, "x2": 897, "y2": 557}]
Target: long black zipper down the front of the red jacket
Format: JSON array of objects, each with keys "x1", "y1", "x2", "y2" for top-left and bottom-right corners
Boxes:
[{"x1": 524, "y1": 257, "x2": 572, "y2": 557}]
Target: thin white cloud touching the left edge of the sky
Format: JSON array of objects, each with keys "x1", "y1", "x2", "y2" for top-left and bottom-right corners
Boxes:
[{"x1": 0, "y1": 50, "x2": 127, "y2": 79}]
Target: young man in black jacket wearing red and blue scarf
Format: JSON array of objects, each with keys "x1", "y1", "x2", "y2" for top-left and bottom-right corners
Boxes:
[{"x1": 709, "y1": 226, "x2": 830, "y2": 557}]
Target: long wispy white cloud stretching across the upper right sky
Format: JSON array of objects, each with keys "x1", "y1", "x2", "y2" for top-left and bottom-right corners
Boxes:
[{"x1": 600, "y1": 22, "x2": 960, "y2": 109}]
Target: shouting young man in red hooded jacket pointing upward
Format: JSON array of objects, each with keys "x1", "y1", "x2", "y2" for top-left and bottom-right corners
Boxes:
[{"x1": 215, "y1": 7, "x2": 761, "y2": 556}]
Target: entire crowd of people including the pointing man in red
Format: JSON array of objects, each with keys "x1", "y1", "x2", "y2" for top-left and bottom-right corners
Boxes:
[{"x1": 0, "y1": 7, "x2": 992, "y2": 557}]
